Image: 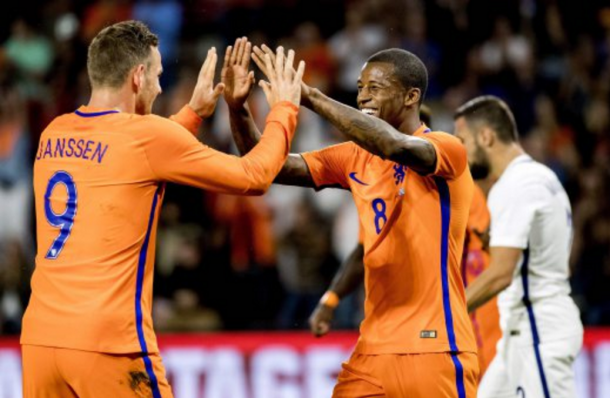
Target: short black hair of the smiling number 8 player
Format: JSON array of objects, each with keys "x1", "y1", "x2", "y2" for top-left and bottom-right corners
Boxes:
[{"x1": 367, "y1": 48, "x2": 428, "y2": 105}]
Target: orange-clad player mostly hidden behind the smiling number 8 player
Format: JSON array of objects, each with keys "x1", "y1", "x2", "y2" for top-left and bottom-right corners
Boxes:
[{"x1": 309, "y1": 105, "x2": 502, "y2": 377}]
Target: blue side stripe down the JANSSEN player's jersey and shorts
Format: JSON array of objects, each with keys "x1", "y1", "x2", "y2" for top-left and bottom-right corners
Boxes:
[{"x1": 135, "y1": 185, "x2": 162, "y2": 398}]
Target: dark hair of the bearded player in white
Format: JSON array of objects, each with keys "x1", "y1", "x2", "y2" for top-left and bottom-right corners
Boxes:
[{"x1": 453, "y1": 95, "x2": 519, "y2": 144}]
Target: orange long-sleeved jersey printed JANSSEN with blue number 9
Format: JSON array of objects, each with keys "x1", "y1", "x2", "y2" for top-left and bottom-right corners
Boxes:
[{"x1": 21, "y1": 102, "x2": 298, "y2": 353}]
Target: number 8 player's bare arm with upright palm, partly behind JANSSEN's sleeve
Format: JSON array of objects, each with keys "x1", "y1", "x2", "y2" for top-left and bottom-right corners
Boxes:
[{"x1": 221, "y1": 37, "x2": 314, "y2": 187}]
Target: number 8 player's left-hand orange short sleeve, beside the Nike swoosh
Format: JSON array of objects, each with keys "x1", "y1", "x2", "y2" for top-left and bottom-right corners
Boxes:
[{"x1": 301, "y1": 142, "x2": 357, "y2": 189}]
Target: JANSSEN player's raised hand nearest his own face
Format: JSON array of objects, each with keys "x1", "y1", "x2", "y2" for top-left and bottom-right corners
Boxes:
[{"x1": 189, "y1": 47, "x2": 225, "y2": 119}]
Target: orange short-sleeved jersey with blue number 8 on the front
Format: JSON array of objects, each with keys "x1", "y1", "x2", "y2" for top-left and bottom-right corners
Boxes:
[{"x1": 303, "y1": 126, "x2": 477, "y2": 355}]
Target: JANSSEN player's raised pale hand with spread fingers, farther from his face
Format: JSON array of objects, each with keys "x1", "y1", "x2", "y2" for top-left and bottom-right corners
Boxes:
[{"x1": 252, "y1": 47, "x2": 305, "y2": 107}]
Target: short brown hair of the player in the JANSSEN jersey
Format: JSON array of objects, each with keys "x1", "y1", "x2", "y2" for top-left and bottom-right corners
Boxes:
[{"x1": 87, "y1": 21, "x2": 159, "y2": 88}]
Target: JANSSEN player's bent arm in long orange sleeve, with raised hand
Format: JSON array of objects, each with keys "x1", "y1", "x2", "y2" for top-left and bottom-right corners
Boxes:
[{"x1": 145, "y1": 47, "x2": 304, "y2": 194}]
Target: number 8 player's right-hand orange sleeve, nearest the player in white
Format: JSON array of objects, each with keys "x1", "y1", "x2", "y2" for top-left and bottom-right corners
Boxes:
[{"x1": 419, "y1": 132, "x2": 468, "y2": 180}]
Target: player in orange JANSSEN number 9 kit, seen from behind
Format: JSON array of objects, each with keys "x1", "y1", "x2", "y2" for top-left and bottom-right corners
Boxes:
[{"x1": 21, "y1": 21, "x2": 304, "y2": 398}]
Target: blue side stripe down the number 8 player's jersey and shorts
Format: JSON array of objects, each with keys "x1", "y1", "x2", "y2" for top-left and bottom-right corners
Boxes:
[{"x1": 434, "y1": 177, "x2": 466, "y2": 398}]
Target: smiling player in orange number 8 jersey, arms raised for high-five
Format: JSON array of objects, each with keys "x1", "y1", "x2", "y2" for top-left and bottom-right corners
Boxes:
[{"x1": 225, "y1": 42, "x2": 478, "y2": 398}]
